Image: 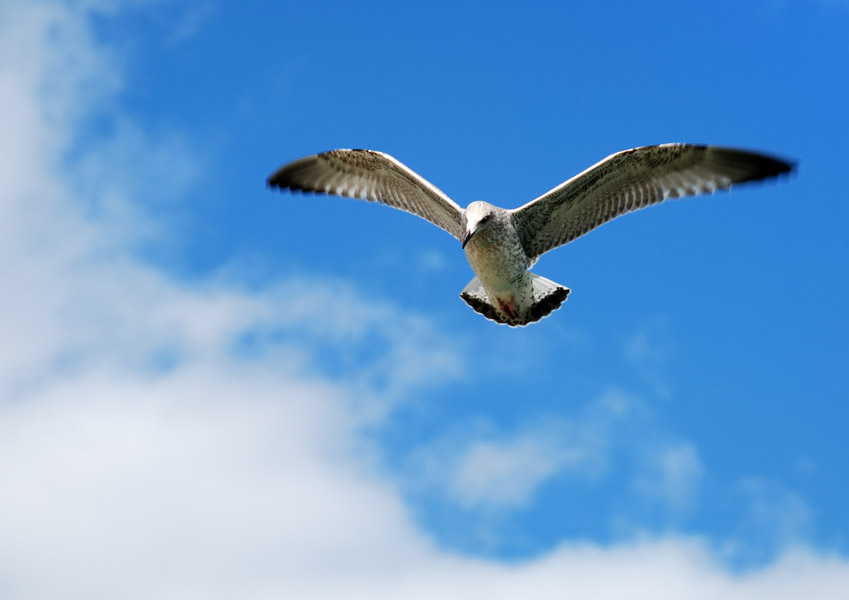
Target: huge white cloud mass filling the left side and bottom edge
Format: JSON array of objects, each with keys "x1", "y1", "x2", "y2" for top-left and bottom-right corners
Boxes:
[{"x1": 0, "y1": 2, "x2": 849, "y2": 600}]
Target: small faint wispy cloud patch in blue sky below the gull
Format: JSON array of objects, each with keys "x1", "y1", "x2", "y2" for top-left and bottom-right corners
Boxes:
[{"x1": 406, "y1": 388, "x2": 703, "y2": 517}]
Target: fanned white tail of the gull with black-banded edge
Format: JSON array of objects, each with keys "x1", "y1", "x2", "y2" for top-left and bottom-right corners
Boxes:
[{"x1": 460, "y1": 273, "x2": 571, "y2": 327}]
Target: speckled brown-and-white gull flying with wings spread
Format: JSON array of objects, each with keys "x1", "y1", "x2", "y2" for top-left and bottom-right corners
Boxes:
[{"x1": 268, "y1": 144, "x2": 795, "y2": 327}]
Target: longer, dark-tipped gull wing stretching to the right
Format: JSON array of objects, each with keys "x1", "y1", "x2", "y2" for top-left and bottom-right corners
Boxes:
[{"x1": 512, "y1": 144, "x2": 794, "y2": 261}]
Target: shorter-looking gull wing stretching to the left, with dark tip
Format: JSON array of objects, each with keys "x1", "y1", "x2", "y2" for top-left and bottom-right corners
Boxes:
[{"x1": 268, "y1": 150, "x2": 463, "y2": 240}]
